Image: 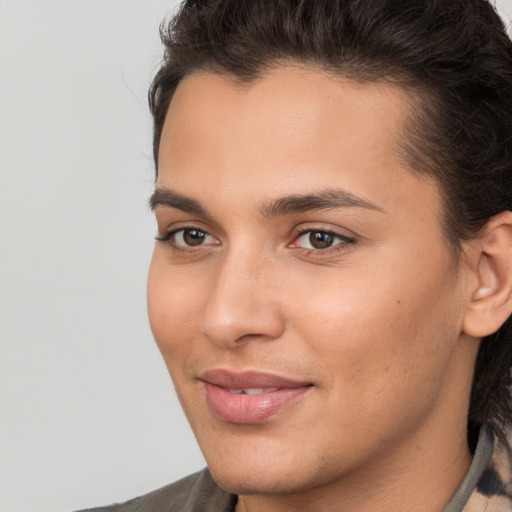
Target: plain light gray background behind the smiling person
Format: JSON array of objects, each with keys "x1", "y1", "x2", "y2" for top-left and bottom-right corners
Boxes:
[{"x1": 0, "y1": 0, "x2": 512, "y2": 512}]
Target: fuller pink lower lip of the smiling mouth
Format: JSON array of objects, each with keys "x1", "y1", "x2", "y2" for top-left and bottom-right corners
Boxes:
[{"x1": 205, "y1": 382, "x2": 311, "y2": 424}]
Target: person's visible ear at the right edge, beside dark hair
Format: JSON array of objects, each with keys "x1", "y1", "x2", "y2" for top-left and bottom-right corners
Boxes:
[{"x1": 462, "y1": 211, "x2": 512, "y2": 338}]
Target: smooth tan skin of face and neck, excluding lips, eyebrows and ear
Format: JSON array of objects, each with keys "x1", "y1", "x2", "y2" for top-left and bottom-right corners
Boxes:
[{"x1": 148, "y1": 67, "x2": 478, "y2": 512}]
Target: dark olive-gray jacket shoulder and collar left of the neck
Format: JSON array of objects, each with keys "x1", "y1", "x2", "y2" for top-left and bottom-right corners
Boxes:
[{"x1": 75, "y1": 469, "x2": 236, "y2": 512}]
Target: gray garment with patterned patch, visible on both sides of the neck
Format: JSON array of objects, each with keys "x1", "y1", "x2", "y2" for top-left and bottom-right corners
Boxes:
[{"x1": 77, "y1": 426, "x2": 512, "y2": 512}]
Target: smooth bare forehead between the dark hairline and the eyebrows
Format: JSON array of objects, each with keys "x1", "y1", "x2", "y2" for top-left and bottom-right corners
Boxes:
[{"x1": 159, "y1": 67, "x2": 440, "y2": 221}]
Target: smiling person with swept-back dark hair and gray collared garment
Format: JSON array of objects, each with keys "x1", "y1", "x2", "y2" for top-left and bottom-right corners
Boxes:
[{"x1": 79, "y1": 0, "x2": 512, "y2": 512}]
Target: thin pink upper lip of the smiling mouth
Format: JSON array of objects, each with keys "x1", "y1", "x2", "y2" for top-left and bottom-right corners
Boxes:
[{"x1": 199, "y1": 369, "x2": 312, "y2": 389}]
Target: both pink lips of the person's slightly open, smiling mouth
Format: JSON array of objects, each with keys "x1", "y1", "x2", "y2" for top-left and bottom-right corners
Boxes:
[{"x1": 201, "y1": 369, "x2": 312, "y2": 424}]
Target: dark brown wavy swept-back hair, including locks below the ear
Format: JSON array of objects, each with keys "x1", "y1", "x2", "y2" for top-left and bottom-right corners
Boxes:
[{"x1": 149, "y1": 0, "x2": 512, "y2": 436}]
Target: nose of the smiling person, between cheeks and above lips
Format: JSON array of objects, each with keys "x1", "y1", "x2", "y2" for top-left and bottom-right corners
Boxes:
[{"x1": 200, "y1": 247, "x2": 285, "y2": 348}]
